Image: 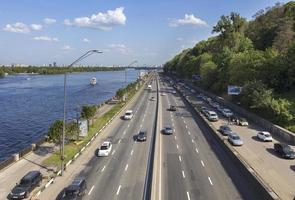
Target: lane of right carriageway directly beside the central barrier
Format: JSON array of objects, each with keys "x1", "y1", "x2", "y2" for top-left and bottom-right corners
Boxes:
[{"x1": 160, "y1": 82, "x2": 186, "y2": 200}]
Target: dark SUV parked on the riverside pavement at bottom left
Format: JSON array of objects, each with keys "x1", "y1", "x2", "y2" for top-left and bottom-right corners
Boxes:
[{"x1": 7, "y1": 171, "x2": 42, "y2": 199}]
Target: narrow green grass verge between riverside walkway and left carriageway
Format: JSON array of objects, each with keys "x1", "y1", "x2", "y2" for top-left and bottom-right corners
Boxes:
[{"x1": 42, "y1": 82, "x2": 143, "y2": 170}]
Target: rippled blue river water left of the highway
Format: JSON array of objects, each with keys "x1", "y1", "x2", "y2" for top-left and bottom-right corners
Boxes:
[{"x1": 0, "y1": 69, "x2": 138, "y2": 161}]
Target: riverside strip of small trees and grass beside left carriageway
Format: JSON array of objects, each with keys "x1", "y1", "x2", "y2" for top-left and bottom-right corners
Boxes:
[{"x1": 42, "y1": 76, "x2": 146, "y2": 169}]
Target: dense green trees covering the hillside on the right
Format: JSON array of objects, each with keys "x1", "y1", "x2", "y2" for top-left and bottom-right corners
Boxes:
[{"x1": 164, "y1": 2, "x2": 295, "y2": 132}]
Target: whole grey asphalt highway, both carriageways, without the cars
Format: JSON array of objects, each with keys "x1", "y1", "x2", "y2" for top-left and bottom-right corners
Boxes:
[{"x1": 40, "y1": 73, "x2": 276, "y2": 200}]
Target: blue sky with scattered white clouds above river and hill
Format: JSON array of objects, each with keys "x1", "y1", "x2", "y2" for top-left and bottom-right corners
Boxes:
[{"x1": 0, "y1": 0, "x2": 288, "y2": 66}]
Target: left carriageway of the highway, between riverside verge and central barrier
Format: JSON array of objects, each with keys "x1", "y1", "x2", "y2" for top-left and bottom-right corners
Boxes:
[{"x1": 79, "y1": 78, "x2": 156, "y2": 200}]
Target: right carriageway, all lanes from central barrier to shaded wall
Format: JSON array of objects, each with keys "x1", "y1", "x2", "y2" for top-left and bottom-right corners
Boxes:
[{"x1": 157, "y1": 76, "x2": 268, "y2": 200}]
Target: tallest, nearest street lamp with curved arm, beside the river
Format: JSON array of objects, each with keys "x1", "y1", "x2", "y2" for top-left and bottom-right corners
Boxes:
[{"x1": 60, "y1": 49, "x2": 102, "y2": 176}]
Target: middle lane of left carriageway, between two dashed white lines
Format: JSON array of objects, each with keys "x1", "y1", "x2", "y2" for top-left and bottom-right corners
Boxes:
[{"x1": 84, "y1": 80, "x2": 156, "y2": 199}]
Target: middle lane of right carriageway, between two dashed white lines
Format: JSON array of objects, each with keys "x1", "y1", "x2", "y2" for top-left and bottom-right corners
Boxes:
[{"x1": 168, "y1": 85, "x2": 218, "y2": 199}]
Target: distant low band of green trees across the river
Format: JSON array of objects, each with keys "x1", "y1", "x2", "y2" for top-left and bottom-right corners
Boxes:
[{"x1": 0, "y1": 66, "x2": 124, "y2": 76}]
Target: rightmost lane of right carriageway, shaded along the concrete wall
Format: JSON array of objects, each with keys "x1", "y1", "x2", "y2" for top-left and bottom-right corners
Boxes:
[{"x1": 166, "y1": 83, "x2": 268, "y2": 199}]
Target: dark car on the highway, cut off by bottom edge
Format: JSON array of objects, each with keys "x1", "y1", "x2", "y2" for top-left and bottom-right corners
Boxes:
[{"x1": 62, "y1": 178, "x2": 87, "y2": 200}]
